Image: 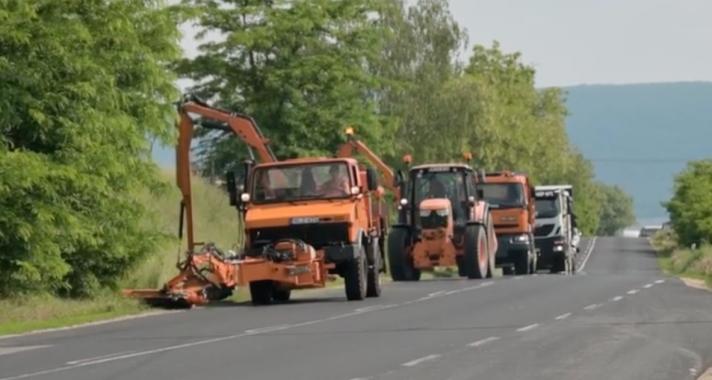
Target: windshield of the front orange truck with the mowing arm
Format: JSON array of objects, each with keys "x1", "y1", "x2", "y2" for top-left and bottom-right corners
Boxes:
[{"x1": 252, "y1": 162, "x2": 351, "y2": 203}]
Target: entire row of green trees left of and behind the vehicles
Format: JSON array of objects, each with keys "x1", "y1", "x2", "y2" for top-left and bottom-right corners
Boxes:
[{"x1": 0, "y1": 0, "x2": 636, "y2": 297}]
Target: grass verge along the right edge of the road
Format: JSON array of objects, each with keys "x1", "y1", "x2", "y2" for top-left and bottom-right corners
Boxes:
[{"x1": 651, "y1": 231, "x2": 712, "y2": 288}]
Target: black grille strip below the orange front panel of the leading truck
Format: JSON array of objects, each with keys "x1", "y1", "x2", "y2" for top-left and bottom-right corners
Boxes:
[{"x1": 250, "y1": 223, "x2": 349, "y2": 249}]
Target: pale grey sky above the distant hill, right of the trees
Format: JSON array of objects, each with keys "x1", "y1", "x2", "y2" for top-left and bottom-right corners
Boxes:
[{"x1": 450, "y1": 0, "x2": 712, "y2": 87}]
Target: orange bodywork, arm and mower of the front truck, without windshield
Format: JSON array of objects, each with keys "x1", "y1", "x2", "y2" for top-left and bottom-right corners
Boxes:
[{"x1": 124, "y1": 99, "x2": 385, "y2": 306}]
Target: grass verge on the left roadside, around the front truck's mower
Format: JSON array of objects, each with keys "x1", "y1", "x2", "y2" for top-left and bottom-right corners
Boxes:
[{"x1": 0, "y1": 173, "x2": 242, "y2": 335}]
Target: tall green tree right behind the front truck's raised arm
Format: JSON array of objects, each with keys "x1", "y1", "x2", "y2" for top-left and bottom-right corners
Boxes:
[{"x1": 180, "y1": 0, "x2": 390, "y2": 170}]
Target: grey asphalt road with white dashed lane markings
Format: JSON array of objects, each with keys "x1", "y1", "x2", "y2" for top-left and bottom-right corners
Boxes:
[{"x1": 0, "y1": 238, "x2": 712, "y2": 380}]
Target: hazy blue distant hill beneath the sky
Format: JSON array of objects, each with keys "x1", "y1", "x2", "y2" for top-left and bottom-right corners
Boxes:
[{"x1": 565, "y1": 82, "x2": 712, "y2": 224}]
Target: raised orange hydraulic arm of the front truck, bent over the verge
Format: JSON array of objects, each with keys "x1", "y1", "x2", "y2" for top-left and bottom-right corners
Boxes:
[{"x1": 176, "y1": 97, "x2": 277, "y2": 252}]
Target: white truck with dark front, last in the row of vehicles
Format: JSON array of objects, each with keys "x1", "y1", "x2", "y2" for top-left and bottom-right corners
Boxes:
[{"x1": 534, "y1": 185, "x2": 579, "y2": 273}]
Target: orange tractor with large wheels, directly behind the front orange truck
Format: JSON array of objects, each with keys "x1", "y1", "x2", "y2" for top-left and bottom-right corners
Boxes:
[{"x1": 388, "y1": 156, "x2": 497, "y2": 281}]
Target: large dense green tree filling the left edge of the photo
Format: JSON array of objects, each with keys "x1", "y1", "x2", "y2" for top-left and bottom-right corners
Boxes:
[{"x1": 0, "y1": 0, "x2": 180, "y2": 296}]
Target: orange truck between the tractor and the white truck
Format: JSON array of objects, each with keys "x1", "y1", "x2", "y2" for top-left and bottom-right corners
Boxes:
[{"x1": 480, "y1": 171, "x2": 537, "y2": 275}]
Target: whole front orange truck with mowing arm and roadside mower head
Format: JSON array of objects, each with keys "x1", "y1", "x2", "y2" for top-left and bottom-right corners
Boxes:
[{"x1": 125, "y1": 99, "x2": 386, "y2": 306}]
